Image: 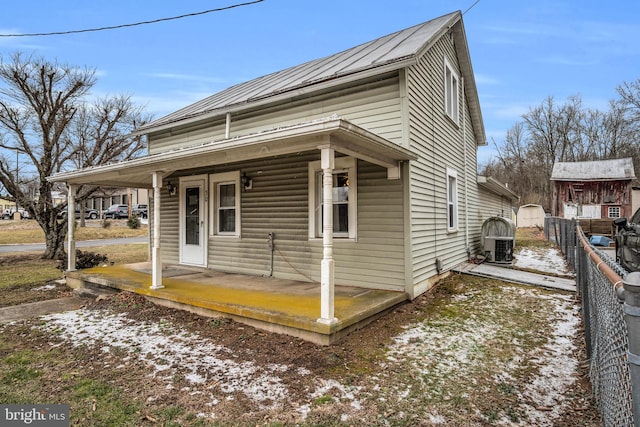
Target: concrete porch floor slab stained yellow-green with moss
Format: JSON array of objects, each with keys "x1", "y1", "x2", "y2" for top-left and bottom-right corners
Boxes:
[{"x1": 67, "y1": 263, "x2": 407, "y2": 345}]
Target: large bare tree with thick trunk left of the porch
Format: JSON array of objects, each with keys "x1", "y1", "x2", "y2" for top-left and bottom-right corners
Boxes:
[{"x1": 0, "y1": 53, "x2": 146, "y2": 259}]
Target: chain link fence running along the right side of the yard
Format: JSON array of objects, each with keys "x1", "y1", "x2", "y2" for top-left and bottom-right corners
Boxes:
[{"x1": 544, "y1": 217, "x2": 634, "y2": 427}]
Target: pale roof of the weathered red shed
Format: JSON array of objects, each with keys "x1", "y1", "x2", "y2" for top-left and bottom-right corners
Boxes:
[{"x1": 551, "y1": 158, "x2": 636, "y2": 181}]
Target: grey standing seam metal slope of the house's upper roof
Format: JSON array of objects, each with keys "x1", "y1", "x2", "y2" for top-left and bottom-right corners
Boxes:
[{"x1": 136, "y1": 12, "x2": 461, "y2": 134}]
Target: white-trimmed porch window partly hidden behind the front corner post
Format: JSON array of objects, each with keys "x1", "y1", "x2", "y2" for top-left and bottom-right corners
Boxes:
[{"x1": 309, "y1": 157, "x2": 357, "y2": 239}]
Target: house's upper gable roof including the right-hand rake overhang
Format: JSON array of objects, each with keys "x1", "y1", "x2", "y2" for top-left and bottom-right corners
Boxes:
[{"x1": 135, "y1": 11, "x2": 486, "y2": 145}]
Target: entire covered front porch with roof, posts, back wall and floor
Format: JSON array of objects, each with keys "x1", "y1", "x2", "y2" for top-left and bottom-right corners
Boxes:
[{"x1": 49, "y1": 116, "x2": 417, "y2": 342}]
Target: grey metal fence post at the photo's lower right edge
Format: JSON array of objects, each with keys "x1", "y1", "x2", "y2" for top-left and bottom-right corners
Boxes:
[{"x1": 623, "y1": 272, "x2": 640, "y2": 427}]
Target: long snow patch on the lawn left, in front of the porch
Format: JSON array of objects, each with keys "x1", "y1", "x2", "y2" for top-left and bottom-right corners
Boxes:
[{"x1": 34, "y1": 309, "x2": 362, "y2": 417}]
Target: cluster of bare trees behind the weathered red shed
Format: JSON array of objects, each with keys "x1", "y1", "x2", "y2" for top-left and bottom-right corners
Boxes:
[{"x1": 484, "y1": 92, "x2": 640, "y2": 209}]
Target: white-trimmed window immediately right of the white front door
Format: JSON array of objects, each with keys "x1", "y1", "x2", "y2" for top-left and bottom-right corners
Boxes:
[{"x1": 209, "y1": 171, "x2": 240, "y2": 237}]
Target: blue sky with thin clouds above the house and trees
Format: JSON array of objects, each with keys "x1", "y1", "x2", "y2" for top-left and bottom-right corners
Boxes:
[{"x1": 0, "y1": 0, "x2": 640, "y2": 163}]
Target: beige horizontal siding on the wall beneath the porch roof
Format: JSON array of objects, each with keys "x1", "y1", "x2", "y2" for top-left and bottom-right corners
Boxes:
[{"x1": 161, "y1": 152, "x2": 405, "y2": 291}]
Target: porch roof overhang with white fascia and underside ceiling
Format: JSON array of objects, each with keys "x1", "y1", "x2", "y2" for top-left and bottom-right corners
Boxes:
[{"x1": 48, "y1": 117, "x2": 417, "y2": 188}]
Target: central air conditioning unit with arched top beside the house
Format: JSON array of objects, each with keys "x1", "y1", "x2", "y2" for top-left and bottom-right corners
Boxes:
[{"x1": 481, "y1": 216, "x2": 516, "y2": 264}]
